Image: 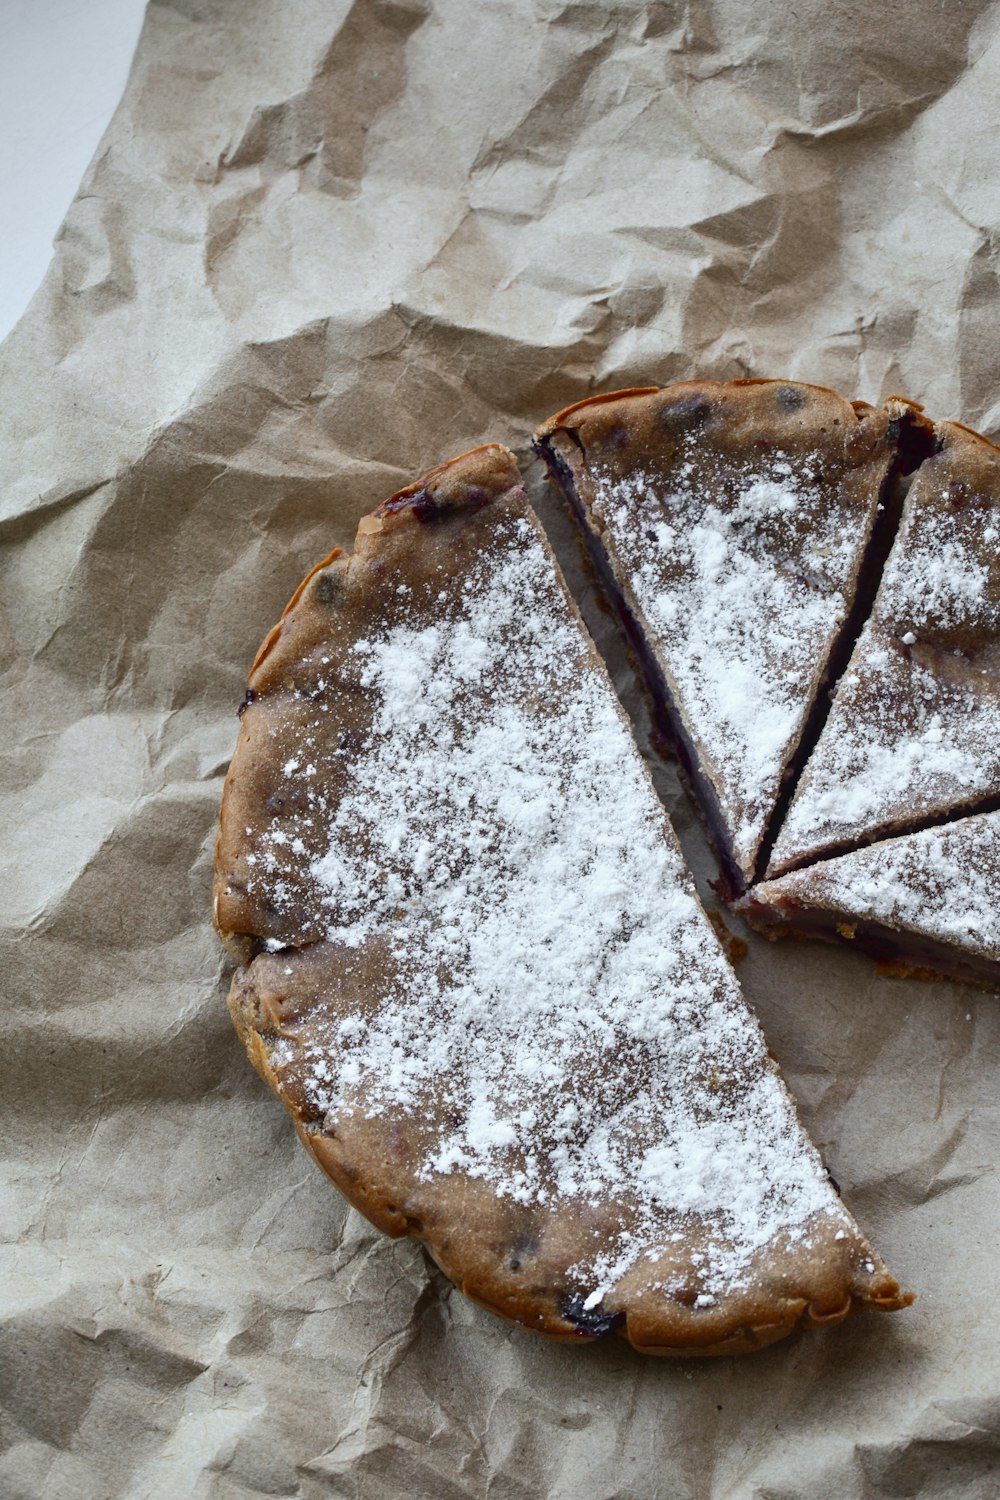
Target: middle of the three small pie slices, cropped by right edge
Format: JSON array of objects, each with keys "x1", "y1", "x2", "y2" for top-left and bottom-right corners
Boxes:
[{"x1": 768, "y1": 423, "x2": 1000, "y2": 878}]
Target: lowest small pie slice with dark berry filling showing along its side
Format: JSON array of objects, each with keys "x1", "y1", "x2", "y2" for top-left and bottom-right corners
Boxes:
[{"x1": 736, "y1": 813, "x2": 1000, "y2": 989}]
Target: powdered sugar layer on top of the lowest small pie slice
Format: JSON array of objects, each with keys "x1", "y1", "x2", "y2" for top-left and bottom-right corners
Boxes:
[{"x1": 756, "y1": 813, "x2": 1000, "y2": 960}]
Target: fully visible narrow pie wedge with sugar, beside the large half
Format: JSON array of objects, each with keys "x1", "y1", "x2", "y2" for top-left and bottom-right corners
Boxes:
[{"x1": 535, "y1": 381, "x2": 919, "y2": 894}]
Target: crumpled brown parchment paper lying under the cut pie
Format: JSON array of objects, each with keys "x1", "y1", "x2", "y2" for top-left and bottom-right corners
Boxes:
[{"x1": 0, "y1": 0, "x2": 1000, "y2": 1500}]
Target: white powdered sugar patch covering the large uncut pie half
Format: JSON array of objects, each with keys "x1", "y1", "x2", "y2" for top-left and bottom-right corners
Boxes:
[{"x1": 239, "y1": 518, "x2": 850, "y2": 1305}]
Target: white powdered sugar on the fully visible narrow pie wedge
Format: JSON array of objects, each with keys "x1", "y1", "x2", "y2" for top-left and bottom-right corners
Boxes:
[{"x1": 594, "y1": 450, "x2": 874, "y2": 876}]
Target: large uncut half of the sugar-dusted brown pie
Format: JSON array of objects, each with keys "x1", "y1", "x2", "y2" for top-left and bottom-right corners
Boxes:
[{"x1": 216, "y1": 446, "x2": 909, "y2": 1353}]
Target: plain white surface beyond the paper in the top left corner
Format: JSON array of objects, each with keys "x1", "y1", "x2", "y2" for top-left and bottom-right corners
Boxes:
[{"x1": 0, "y1": 0, "x2": 145, "y2": 339}]
